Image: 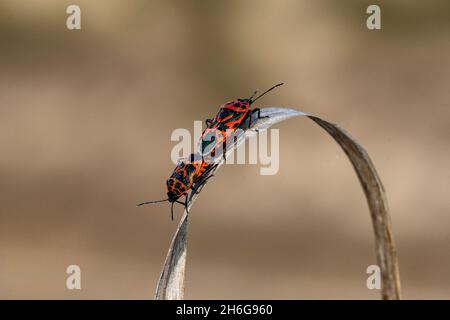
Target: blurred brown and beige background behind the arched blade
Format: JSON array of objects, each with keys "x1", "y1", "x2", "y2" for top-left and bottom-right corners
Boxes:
[{"x1": 0, "y1": 0, "x2": 450, "y2": 299}]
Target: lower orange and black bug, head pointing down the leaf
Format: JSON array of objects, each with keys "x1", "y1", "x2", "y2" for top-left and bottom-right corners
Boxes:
[{"x1": 138, "y1": 154, "x2": 216, "y2": 220}]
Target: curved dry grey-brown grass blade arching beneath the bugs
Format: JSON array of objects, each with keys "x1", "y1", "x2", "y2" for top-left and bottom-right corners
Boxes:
[{"x1": 155, "y1": 107, "x2": 401, "y2": 300}]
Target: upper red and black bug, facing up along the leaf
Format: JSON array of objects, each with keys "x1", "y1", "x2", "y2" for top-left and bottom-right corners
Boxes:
[{"x1": 200, "y1": 83, "x2": 283, "y2": 158}]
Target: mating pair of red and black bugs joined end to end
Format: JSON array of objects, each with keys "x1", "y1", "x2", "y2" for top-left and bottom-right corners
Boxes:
[{"x1": 138, "y1": 83, "x2": 283, "y2": 220}]
